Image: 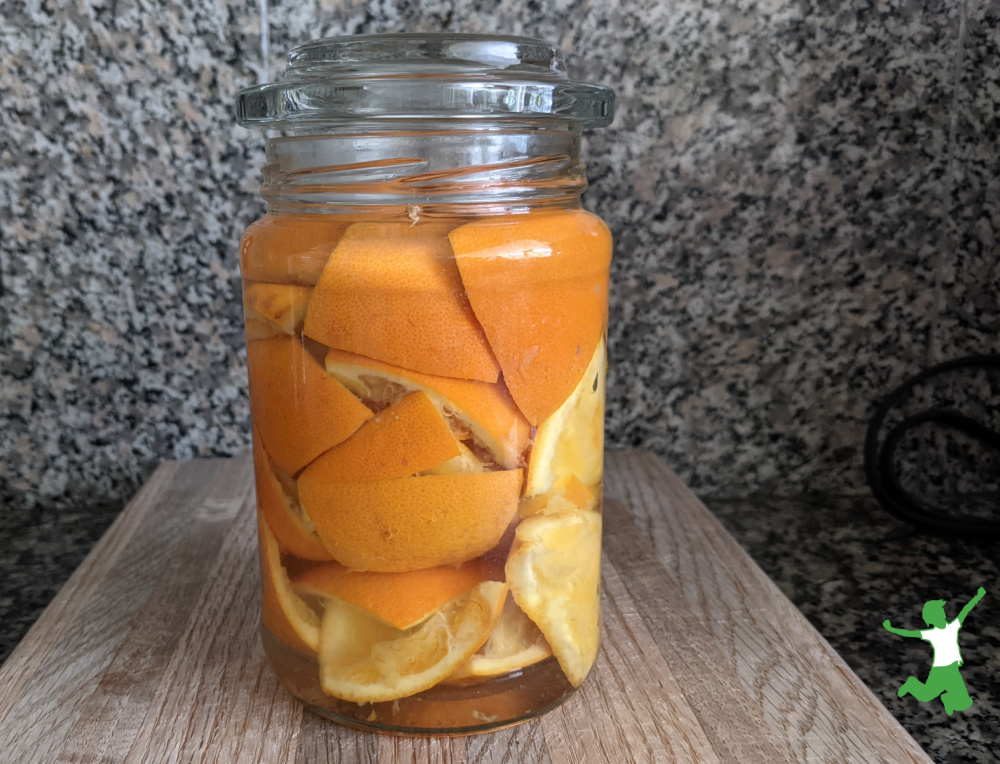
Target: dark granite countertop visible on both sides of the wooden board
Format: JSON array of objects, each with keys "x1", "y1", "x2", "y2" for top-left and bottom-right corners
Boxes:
[{"x1": 0, "y1": 468, "x2": 1000, "y2": 764}]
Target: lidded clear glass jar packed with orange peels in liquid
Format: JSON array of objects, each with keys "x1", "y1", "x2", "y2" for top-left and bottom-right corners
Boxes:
[{"x1": 238, "y1": 35, "x2": 613, "y2": 733}]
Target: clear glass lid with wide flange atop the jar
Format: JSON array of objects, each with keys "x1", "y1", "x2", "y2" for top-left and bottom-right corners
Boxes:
[{"x1": 236, "y1": 34, "x2": 614, "y2": 129}]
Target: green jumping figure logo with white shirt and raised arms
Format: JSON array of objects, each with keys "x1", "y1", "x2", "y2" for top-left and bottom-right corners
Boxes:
[{"x1": 882, "y1": 586, "x2": 986, "y2": 716}]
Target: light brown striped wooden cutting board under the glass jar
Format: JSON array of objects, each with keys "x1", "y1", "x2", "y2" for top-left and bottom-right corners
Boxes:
[{"x1": 0, "y1": 452, "x2": 930, "y2": 764}]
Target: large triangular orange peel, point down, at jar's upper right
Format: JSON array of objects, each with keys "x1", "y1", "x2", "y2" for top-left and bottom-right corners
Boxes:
[{"x1": 448, "y1": 210, "x2": 611, "y2": 425}]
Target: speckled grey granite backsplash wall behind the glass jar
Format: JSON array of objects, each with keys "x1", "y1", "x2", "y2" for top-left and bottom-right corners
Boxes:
[{"x1": 0, "y1": 0, "x2": 1000, "y2": 508}]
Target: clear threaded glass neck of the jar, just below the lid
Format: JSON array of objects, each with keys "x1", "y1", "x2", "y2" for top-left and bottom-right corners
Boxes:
[{"x1": 261, "y1": 123, "x2": 587, "y2": 216}]
